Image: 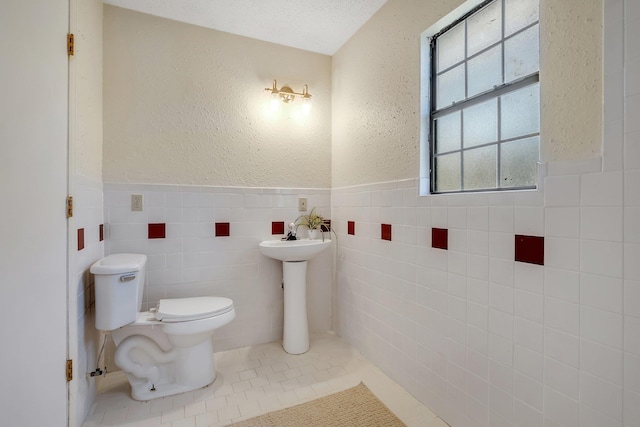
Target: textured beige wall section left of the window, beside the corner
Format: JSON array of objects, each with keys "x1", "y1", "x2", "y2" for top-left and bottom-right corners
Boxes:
[{"x1": 332, "y1": 0, "x2": 462, "y2": 187}]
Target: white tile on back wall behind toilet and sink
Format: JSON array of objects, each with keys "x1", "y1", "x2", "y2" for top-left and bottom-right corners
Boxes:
[{"x1": 105, "y1": 183, "x2": 332, "y2": 351}]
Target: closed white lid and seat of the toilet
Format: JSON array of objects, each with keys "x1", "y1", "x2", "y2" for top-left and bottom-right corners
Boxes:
[{"x1": 156, "y1": 297, "x2": 233, "y2": 322}]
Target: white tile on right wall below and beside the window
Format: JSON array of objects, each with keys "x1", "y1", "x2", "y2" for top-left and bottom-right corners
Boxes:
[{"x1": 332, "y1": 5, "x2": 640, "y2": 427}]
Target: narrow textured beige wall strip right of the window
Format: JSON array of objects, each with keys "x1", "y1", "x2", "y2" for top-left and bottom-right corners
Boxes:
[{"x1": 540, "y1": 0, "x2": 603, "y2": 162}]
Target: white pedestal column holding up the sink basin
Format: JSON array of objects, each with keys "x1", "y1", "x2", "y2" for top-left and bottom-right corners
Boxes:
[{"x1": 282, "y1": 261, "x2": 309, "y2": 354}]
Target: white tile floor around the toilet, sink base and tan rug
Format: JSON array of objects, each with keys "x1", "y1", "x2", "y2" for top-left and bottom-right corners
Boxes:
[{"x1": 83, "y1": 333, "x2": 447, "y2": 427}]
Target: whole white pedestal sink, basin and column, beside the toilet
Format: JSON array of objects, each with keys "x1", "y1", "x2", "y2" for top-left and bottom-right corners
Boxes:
[{"x1": 259, "y1": 239, "x2": 331, "y2": 354}]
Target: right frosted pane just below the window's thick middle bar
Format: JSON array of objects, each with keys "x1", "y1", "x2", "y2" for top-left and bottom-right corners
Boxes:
[{"x1": 500, "y1": 83, "x2": 540, "y2": 140}]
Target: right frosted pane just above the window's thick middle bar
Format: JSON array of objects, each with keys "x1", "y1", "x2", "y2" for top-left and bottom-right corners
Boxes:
[{"x1": 504, "y1": 25, "x2": 540, "y2": 82}]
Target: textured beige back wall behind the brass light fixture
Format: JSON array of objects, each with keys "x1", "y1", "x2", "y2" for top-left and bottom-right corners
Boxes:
[{"x1": 103, "y1": 5, "x2": 331, "y2": 188}]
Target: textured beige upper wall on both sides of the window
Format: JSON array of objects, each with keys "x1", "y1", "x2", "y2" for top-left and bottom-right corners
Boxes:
[{"x1": 332, "y1": 0, "x2": 602, "y2": 187}]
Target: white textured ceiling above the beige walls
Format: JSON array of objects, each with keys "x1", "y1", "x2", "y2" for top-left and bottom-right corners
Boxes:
[{"x1": 103, "y1": 0, "x2": 387, "y2": 55}]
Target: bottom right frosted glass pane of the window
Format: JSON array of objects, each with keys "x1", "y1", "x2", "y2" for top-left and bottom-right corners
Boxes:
[{"x1": 500, "y1": 136, "x2": 540, "y2": 187}]
